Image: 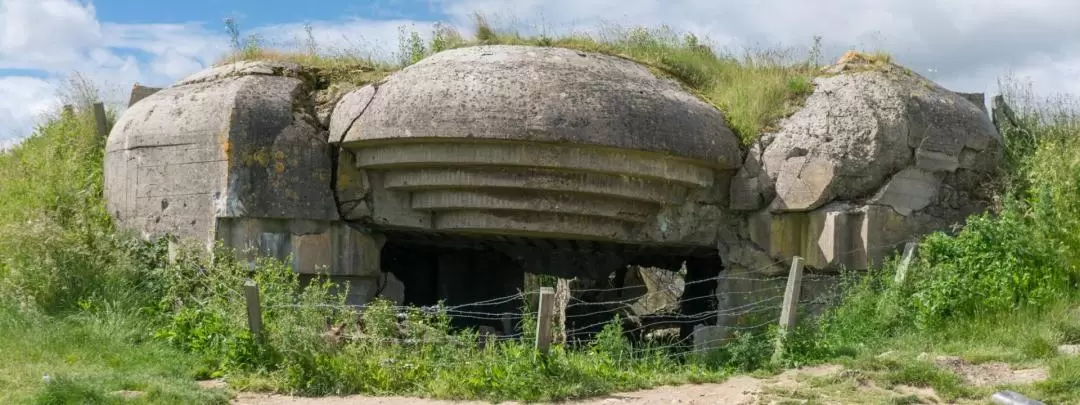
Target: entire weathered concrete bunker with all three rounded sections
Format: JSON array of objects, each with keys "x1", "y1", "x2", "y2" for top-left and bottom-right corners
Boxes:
[{"x1": 105, "y1": 45, "x2": 1001, "y2": 345}]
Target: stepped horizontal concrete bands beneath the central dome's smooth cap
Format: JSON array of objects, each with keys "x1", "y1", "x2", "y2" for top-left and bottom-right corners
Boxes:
[{"x1": 342, "y1": 139, "x2": 715, "y2": 242}]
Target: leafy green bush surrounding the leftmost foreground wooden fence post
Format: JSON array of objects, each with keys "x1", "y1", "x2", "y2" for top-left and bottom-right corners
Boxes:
[{"x1": 154, "y1": 245, "x2": 355, "y2": 377}]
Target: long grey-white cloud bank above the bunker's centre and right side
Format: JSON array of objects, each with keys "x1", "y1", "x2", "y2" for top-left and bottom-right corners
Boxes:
[{"x1": 442, "y1": 0, "x2": 1080, "y2": 96}]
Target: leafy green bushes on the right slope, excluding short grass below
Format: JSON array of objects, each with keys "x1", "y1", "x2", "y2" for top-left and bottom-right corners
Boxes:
[{"x1": 816, "y1": 81, "x2": 1080, "y2": 360}]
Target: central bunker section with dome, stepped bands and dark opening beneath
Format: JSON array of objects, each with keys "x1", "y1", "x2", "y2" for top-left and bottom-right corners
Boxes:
[{"x1": 328, "y1": 46, "x2": 741, "y2": 334}]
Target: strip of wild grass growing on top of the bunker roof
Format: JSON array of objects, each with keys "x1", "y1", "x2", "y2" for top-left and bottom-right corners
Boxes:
[{"x1": 222, "y1": 14, "x2": 820, "y2": 144}]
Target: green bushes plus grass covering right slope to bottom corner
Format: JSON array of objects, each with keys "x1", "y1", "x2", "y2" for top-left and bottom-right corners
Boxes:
[{"x1": 790, "y1": 74, "x2": 1080, "y2": 403}]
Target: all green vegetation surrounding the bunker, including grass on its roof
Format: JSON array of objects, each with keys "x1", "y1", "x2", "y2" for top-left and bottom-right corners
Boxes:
[{"x1": 0, "y1": 13, "x2": 1080, "y2": 404}]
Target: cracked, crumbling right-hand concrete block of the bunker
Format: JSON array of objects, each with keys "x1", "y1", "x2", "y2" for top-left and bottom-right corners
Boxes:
[{"x1": 725, "y1": 56, "x2": 1003, "y2": 273}]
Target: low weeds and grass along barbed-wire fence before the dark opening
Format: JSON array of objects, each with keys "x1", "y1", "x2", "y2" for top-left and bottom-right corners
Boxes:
[{"x1": 157, "y1": 249, "x2": 719, "y2": 400}]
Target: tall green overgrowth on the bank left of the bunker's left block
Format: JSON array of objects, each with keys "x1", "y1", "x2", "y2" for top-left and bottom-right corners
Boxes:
[{"x1": 0, "y1": 96, "x2": 163, "y2": 313}]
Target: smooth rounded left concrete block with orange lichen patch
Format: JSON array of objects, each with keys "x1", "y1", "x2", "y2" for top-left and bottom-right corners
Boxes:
[{"x1": 105, "y1": 63, "x2": 400, "y2": 306}]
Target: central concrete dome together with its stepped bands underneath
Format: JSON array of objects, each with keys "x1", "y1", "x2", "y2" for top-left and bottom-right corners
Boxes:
[{"x1": 329, "y1": 45, "x2": 741, "y2": 245}]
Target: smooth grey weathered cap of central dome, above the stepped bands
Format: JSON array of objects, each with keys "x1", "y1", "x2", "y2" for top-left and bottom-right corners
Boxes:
[{"x1": 332, "y1": 45, "x2": 740, "y2": 168}]
